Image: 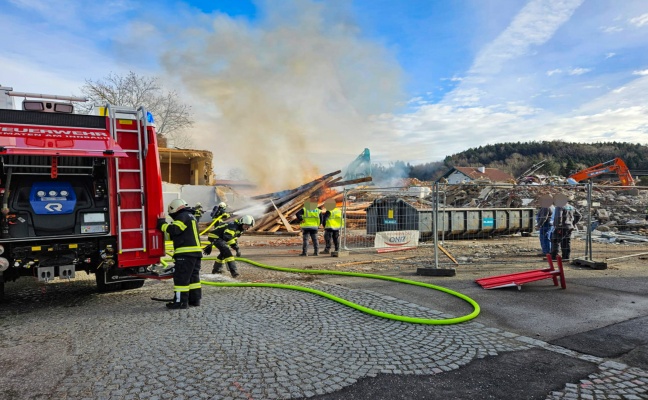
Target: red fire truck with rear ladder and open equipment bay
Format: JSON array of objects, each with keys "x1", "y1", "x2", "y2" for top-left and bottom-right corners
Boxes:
[{"x1": 0, "y1": 87, "x2": 164, "y2": 300}]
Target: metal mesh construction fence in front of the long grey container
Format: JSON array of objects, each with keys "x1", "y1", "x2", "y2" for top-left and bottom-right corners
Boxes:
[{"x1": 340, "y1": 183, "x2": 648, "y2": 267}]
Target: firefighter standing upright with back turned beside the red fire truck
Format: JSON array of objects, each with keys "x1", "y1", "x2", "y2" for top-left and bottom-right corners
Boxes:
[{"x1": 157, "y1": 199, "x2": 202, "y2": 309}]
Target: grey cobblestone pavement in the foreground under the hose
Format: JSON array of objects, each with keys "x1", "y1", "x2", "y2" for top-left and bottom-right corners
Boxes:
[{"x1": 0, "y1": 268, "x2": 648, "y2": 400}]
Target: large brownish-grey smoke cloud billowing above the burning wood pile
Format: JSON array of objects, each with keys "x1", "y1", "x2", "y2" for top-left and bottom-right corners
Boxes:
[{"x1": 161, "y1": 0, "x2": 403, "y2": 191}]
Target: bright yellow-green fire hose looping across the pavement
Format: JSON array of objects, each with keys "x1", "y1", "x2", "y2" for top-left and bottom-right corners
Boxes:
[{"x1": 200, "y1": 257, "x2": 480, "y2": 325}]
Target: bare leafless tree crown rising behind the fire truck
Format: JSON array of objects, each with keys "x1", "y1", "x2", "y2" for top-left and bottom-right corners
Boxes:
[{"x1": 79, "y1": 71, "x2": 194, "y2": 148}]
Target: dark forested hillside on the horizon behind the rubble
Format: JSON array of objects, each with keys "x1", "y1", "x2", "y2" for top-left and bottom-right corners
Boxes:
[{"x1": 372, "y1": 141, "x2": 648, "y2": 181}]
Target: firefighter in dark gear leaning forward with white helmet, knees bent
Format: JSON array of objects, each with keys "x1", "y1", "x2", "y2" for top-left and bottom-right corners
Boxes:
[{"x1": 203, "y1": 215, "x2": 254, "y2": 278}]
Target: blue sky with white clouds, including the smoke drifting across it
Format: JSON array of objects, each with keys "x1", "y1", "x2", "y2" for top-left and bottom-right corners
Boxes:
[{"x1": 0, "y1": 0, "x2": 648, "y2": 188}]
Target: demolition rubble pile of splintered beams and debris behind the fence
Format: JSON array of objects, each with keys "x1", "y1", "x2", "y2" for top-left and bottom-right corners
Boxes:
[{"x1": 239, "y1": 171, "x2": 648, "y2": 242}]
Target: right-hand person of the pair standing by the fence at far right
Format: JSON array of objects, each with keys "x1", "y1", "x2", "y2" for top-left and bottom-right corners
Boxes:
[{"x1": 551, "y1": 193, "x2": 582, "y2": 260}]
